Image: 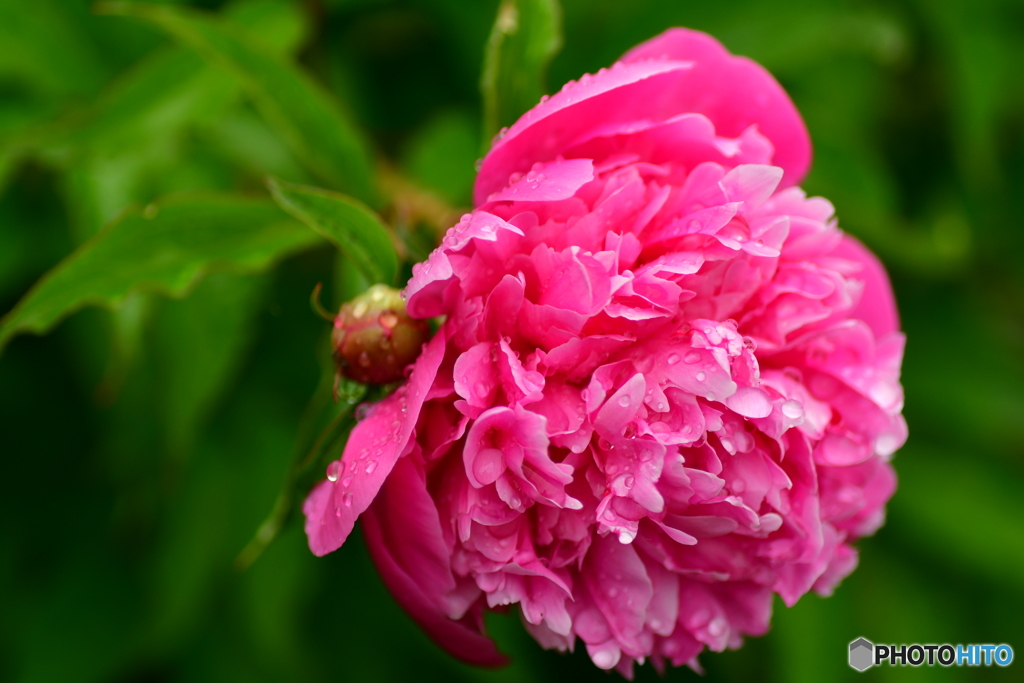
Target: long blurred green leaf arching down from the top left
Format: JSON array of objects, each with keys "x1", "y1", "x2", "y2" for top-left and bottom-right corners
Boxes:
[{"x1": 98, "y1": 2, "x2": 375, "y2": 202}]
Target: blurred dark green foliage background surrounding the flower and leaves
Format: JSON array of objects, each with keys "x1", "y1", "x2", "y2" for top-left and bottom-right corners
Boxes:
[{"x1": 0, "y1": 0, "x2": 1024, "y2": 683}]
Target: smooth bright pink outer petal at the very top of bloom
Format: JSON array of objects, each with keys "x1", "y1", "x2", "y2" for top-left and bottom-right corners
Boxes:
[{"x1": 623, "y1": 29, "x2": 811, "y2": 187}]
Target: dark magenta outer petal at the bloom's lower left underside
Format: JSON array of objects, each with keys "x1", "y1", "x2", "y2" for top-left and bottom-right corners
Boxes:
[{"x1": 362, "y1": 458, "x2": 508, "y2": 667}]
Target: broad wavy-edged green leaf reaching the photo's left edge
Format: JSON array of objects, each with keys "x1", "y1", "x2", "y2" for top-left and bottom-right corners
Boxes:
[{"x1": 0, "y1": 194, "x2": 317, "y2": 349}]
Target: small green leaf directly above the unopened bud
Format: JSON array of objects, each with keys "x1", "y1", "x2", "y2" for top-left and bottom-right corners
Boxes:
[{"x1": 267, "y1": 178, "x2": 398, "y2": 285}]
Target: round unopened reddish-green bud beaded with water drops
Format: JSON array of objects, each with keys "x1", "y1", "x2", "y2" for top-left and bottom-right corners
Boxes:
[{"x1": 332, "y1": 285, "x2": 430, "y2": 384}]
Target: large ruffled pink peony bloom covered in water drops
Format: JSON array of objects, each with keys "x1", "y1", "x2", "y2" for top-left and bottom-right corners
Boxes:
[{"x1": 304, "y1": 29, "x2": 906, "y2": 676}]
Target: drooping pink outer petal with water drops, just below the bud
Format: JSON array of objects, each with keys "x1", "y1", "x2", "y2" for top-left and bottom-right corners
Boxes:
[{"x1": 302, "y1": 334, "x2": 444, "y2": 555}]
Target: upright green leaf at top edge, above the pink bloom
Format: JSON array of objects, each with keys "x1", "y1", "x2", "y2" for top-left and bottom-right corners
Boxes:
[{"x1": 480, "y1": 0, "x2": 562, "y2": 151}]
